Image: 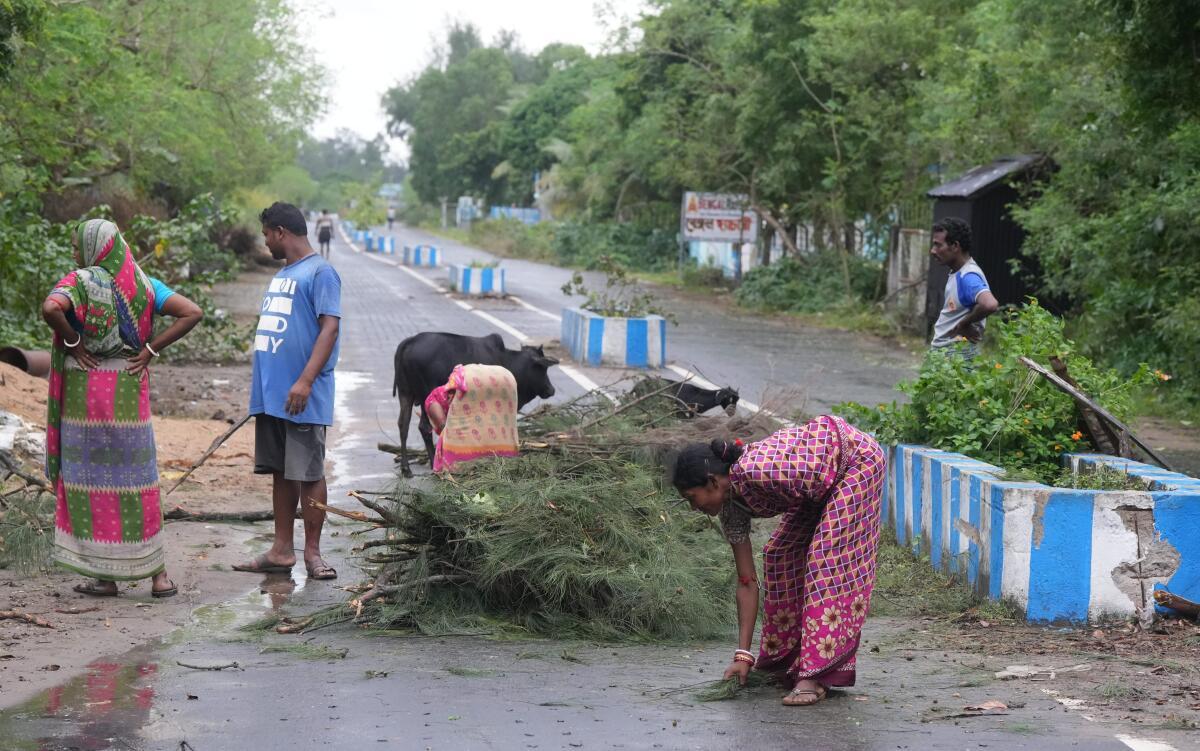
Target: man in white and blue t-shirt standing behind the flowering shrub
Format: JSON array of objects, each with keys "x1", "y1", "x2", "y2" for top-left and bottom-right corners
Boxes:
[{"x1": 930, "y1": 217, "x2": 1000, "y2": 358}]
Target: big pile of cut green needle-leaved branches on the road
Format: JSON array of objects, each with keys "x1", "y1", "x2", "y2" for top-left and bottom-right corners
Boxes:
[{"x1": 320, "y1": 379, "x2": 796, "y2": 641}]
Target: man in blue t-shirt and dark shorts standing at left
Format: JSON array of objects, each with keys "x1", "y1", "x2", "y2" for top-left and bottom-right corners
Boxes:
[{"x1": 234, "y1": 203, "x2": 342, "y2": 579}]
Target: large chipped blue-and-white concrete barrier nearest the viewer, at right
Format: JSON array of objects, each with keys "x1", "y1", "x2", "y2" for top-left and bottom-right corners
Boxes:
[{"x1": 883, "y1": 445, "x2": 1200, "y2": 623}]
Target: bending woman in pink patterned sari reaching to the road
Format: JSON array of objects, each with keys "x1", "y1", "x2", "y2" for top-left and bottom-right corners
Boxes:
[{"x1": 673, "y1": 416, "x2": 886, "y2": 705}]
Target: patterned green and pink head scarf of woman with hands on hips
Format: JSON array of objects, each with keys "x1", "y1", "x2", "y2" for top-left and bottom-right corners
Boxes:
[{"x1": 46, "y1": 220, "x2": 154, "y2": 482}]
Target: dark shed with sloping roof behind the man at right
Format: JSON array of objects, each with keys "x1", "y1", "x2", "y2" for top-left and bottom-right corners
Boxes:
[{"x1": 925, "y1": 154, "x2": 1049, "y2": 330}]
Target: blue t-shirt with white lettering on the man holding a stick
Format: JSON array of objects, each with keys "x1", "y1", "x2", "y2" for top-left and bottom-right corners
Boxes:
[{"x1": 250, "y1": 253, "x2": 342, "y2": 425}]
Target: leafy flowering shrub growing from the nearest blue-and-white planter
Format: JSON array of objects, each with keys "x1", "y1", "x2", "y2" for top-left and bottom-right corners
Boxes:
[{"x1": 835, "y1": 300, "x2": 1156, "y2": 470}]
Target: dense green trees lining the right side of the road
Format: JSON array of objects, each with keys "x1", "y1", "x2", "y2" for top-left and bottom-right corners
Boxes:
[{"x1": 385, "y1": 0, "x2": 1200, "y2": 414}]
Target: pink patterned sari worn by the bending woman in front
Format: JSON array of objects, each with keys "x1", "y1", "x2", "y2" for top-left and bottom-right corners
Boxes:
[{"x1": 730, "y1": 416, "x2": 886, "y2": 686}]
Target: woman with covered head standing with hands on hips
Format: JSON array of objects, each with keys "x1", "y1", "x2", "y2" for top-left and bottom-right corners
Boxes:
[{"x1": 42, "y1": 220, "x2": 203, "y2": 597}]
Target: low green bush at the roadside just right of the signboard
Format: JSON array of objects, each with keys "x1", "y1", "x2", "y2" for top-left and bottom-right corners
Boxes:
[{"x1": 737, "y1": 251, "x2": 881, "y2": 313}]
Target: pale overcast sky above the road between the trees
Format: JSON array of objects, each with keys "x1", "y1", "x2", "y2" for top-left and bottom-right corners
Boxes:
[{"x1": 300, "y1": 0, "x2": 643, "y2": 158}]
